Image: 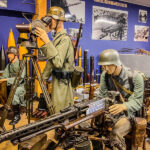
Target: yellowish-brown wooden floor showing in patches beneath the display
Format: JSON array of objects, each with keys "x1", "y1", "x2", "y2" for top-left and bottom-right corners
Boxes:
[{"x1": 0, "y1": 102, "x2": 150, "y2": 150}]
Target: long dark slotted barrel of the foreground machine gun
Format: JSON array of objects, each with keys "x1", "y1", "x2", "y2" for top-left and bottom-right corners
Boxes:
[{"x1": 0, "y1": 104, "x2": 88, "y2": 144}]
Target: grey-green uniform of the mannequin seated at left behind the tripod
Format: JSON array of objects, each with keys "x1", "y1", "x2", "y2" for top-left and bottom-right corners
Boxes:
[{"x1": 0, "y1": 59, "x2": 26, "y2": 106}]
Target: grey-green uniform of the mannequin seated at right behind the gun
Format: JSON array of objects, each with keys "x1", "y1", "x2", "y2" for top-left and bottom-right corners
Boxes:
[{"x1": 98, "y1": 66, "x2": 144, "y2": 150}]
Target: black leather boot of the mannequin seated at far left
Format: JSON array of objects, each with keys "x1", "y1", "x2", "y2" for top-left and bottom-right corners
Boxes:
[{"x1": 9, "y1": 105, "x2": 20, "y2": 125}]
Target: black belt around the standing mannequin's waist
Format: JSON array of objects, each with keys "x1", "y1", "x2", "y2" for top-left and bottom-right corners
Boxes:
[{"x1": 52, "y1": 70, "x2": 72, "y2": 80}]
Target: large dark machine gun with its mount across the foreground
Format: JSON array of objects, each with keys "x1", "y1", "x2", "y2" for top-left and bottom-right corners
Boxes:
[{"x1": 0, "y1": 91, "x2": 124, "y2": 149}]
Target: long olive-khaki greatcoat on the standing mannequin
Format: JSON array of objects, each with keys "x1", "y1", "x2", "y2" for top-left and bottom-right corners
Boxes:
[{"x1": 41, "y1": 30, "x2": 74, "y2": 113}]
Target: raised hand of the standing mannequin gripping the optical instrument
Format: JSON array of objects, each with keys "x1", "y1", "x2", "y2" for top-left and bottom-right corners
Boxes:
[{"x1": 35, "y1": 27, "x2": 50, "y2": 44}]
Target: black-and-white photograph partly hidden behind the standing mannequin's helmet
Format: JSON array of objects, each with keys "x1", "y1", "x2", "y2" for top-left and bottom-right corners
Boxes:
[{"x1": 51, "y1": 0, "x2": 85, "y2": 24}]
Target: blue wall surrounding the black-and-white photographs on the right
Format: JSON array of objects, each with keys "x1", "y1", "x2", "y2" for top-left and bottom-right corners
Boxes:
[{"x1": 62, "y1": 0, "x2": 150, "y2": 70}]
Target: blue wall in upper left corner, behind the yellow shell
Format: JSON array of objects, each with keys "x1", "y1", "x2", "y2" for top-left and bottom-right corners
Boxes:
[{"x1": 0, "y1": 0, "x2": 35, "y2": 57}]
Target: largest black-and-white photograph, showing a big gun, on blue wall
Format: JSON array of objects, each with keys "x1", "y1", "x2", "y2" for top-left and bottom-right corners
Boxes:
[{"x1": 92, "y1": 6, "x2": 128, "y2": 41}]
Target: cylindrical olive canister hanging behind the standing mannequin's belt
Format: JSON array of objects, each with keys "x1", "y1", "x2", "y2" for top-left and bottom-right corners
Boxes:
[{"x1": 71, "y1": 66, "x2": 84, "y2": 88}]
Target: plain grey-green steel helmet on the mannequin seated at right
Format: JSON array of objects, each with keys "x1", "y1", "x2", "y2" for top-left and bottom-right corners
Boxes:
[{"x1": 98, "y1": 49, "x2": 121, "y2": 66}]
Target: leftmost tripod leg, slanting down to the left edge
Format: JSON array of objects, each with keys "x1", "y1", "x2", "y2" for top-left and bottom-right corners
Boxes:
[{"x1": 0, "y1": 58, "x2": 26, "y2": 131}]
